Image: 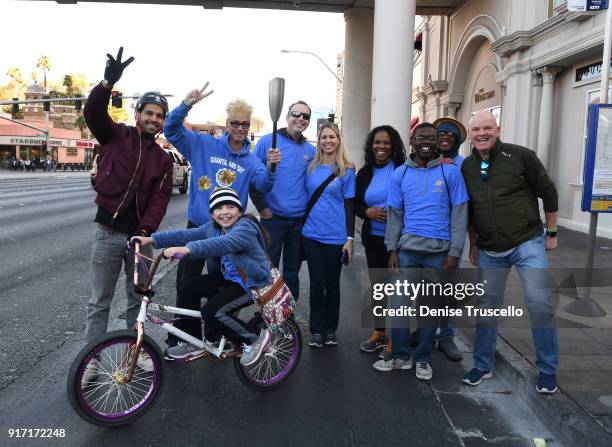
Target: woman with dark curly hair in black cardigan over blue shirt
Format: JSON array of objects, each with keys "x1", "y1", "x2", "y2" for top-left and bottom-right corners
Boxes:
[{"x1": 355, "y1": 125, "x2": 406, "y2": 352}]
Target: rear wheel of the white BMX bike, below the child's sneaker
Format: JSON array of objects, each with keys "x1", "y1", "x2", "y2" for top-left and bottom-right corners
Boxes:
[{"x1": 234, "y1": 319, "x2": 302, "y2": 391}]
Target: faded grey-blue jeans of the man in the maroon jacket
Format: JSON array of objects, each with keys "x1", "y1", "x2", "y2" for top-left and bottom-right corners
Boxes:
[{"x1": 85, "y1": 228, "x2": 153, "y2": 343}]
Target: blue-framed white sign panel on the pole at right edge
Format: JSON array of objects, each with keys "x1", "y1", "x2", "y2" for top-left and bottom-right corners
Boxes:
[{"x1": 582, "y1": 104, "x2": 612, "y2": 213}]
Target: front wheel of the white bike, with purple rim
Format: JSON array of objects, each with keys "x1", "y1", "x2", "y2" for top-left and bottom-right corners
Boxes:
[{"x1": 67, "y1": 330, "x2": 165, "y2": 427}]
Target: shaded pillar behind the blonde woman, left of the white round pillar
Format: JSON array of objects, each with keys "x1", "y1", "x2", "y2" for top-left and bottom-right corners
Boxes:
[{"x1": 342, "y1": 7, "x2": 374, "y2": 166}]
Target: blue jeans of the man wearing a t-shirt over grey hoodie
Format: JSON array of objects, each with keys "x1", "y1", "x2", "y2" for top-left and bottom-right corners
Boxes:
[{"x1": 387, "y1": 250, "x2": 447, "y2": 362}]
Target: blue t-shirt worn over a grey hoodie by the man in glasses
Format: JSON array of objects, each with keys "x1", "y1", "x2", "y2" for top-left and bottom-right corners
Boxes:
[{"x1": 387, "y1": 164, "x2": 469, "y2": 241}]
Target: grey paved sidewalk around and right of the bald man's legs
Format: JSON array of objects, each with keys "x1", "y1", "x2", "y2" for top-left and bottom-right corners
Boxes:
[{"x1": 490, "y1": 228, "x2": 612, "y2": 445}]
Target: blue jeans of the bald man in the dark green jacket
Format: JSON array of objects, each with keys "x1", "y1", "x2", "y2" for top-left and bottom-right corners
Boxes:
[{"x1": 474, "y1": 235, "x2": 559, "y2": 374}]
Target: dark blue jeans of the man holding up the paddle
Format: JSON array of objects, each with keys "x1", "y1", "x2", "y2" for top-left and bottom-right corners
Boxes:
[{"x1": 261, "y1": 216, "x2": 302, "y2": 300}]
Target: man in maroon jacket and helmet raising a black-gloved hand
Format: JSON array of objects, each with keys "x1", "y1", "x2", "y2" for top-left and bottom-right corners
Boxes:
[{"x1": 83, "y1": 47, "x2": 172, "y2": 350}]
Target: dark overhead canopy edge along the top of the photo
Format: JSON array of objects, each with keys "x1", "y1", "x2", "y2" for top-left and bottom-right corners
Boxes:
[{"x1": 56, "y1": 0, "x2": 464, "y2": 15}]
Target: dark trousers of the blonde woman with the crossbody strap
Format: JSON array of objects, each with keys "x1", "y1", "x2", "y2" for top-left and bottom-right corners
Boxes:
[{"x1": 302, "y1": 237, "x2": 342, "y2": 334}]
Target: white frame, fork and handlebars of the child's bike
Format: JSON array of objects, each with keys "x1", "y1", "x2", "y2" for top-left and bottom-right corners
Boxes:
[{"x1": 126, "y1": 243, "x2": 235, "y2": 382}]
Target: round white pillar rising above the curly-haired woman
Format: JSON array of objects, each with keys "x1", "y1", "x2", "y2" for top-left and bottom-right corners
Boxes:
[{"x1": 371, "y1": 0, "x2": 416, "y2": 145}]
